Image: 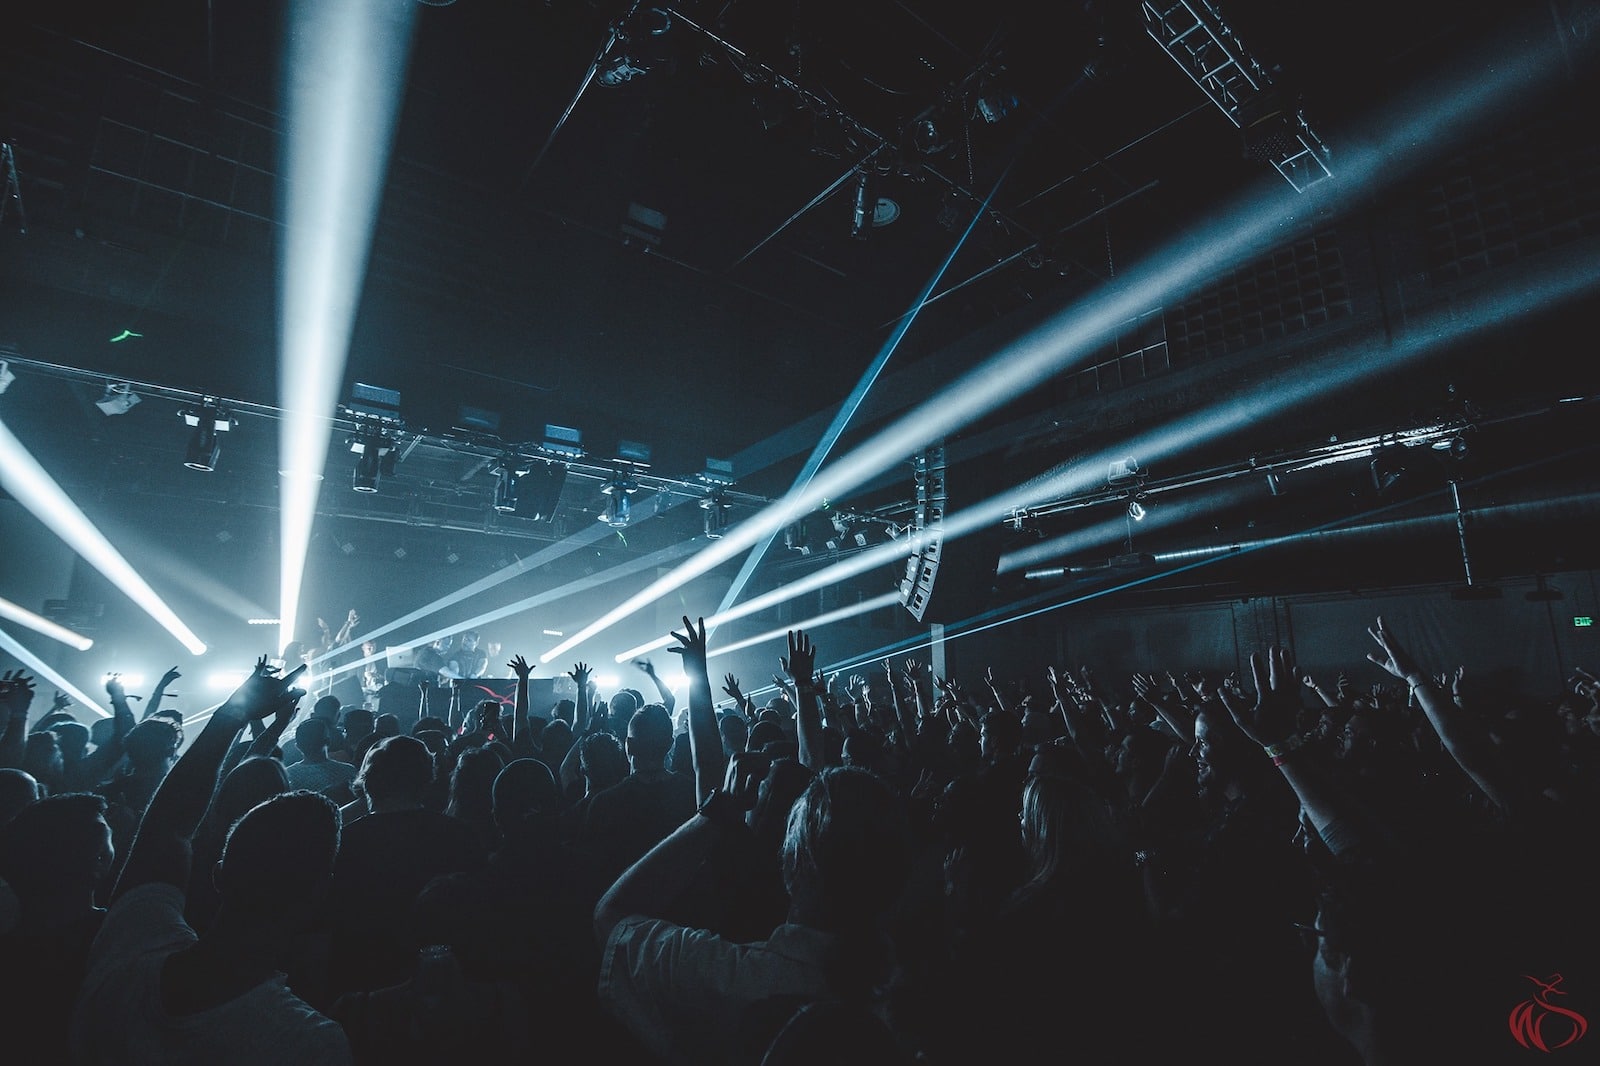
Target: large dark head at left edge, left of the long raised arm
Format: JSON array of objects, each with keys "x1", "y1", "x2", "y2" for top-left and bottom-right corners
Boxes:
[{"x1": 0, "y1": 792, "x2": 117, "y2": 911}]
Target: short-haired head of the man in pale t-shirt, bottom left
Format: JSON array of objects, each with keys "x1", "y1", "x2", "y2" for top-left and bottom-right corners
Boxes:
[{"x1": 214, "y1": 791, "x2": 339, "y2": 932}]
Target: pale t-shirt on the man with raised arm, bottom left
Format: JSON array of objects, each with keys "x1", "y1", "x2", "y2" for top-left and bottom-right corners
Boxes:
[{"x1": 69, "y1": 882, "x2": 350, "y2": 1066}]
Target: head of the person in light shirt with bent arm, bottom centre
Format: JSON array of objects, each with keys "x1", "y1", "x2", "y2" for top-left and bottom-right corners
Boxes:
[{"x1": 782, "y1": 767, "x2": 910, "y2": 933}]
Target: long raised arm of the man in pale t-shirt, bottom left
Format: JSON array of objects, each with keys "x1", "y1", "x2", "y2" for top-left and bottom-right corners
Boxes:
[{"x1": 112, "y1": 658, "x2": 306, "y2": 900}]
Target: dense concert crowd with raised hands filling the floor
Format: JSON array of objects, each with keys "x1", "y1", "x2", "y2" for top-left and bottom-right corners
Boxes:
[{"x1": 0, "y1": 611, "x2": 1600, "y2": 1066}]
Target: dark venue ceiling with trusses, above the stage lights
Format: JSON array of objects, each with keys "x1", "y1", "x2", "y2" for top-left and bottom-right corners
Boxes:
[{"x1": 0, "y1": 0, "x2": 1600, "y2": 656}]
